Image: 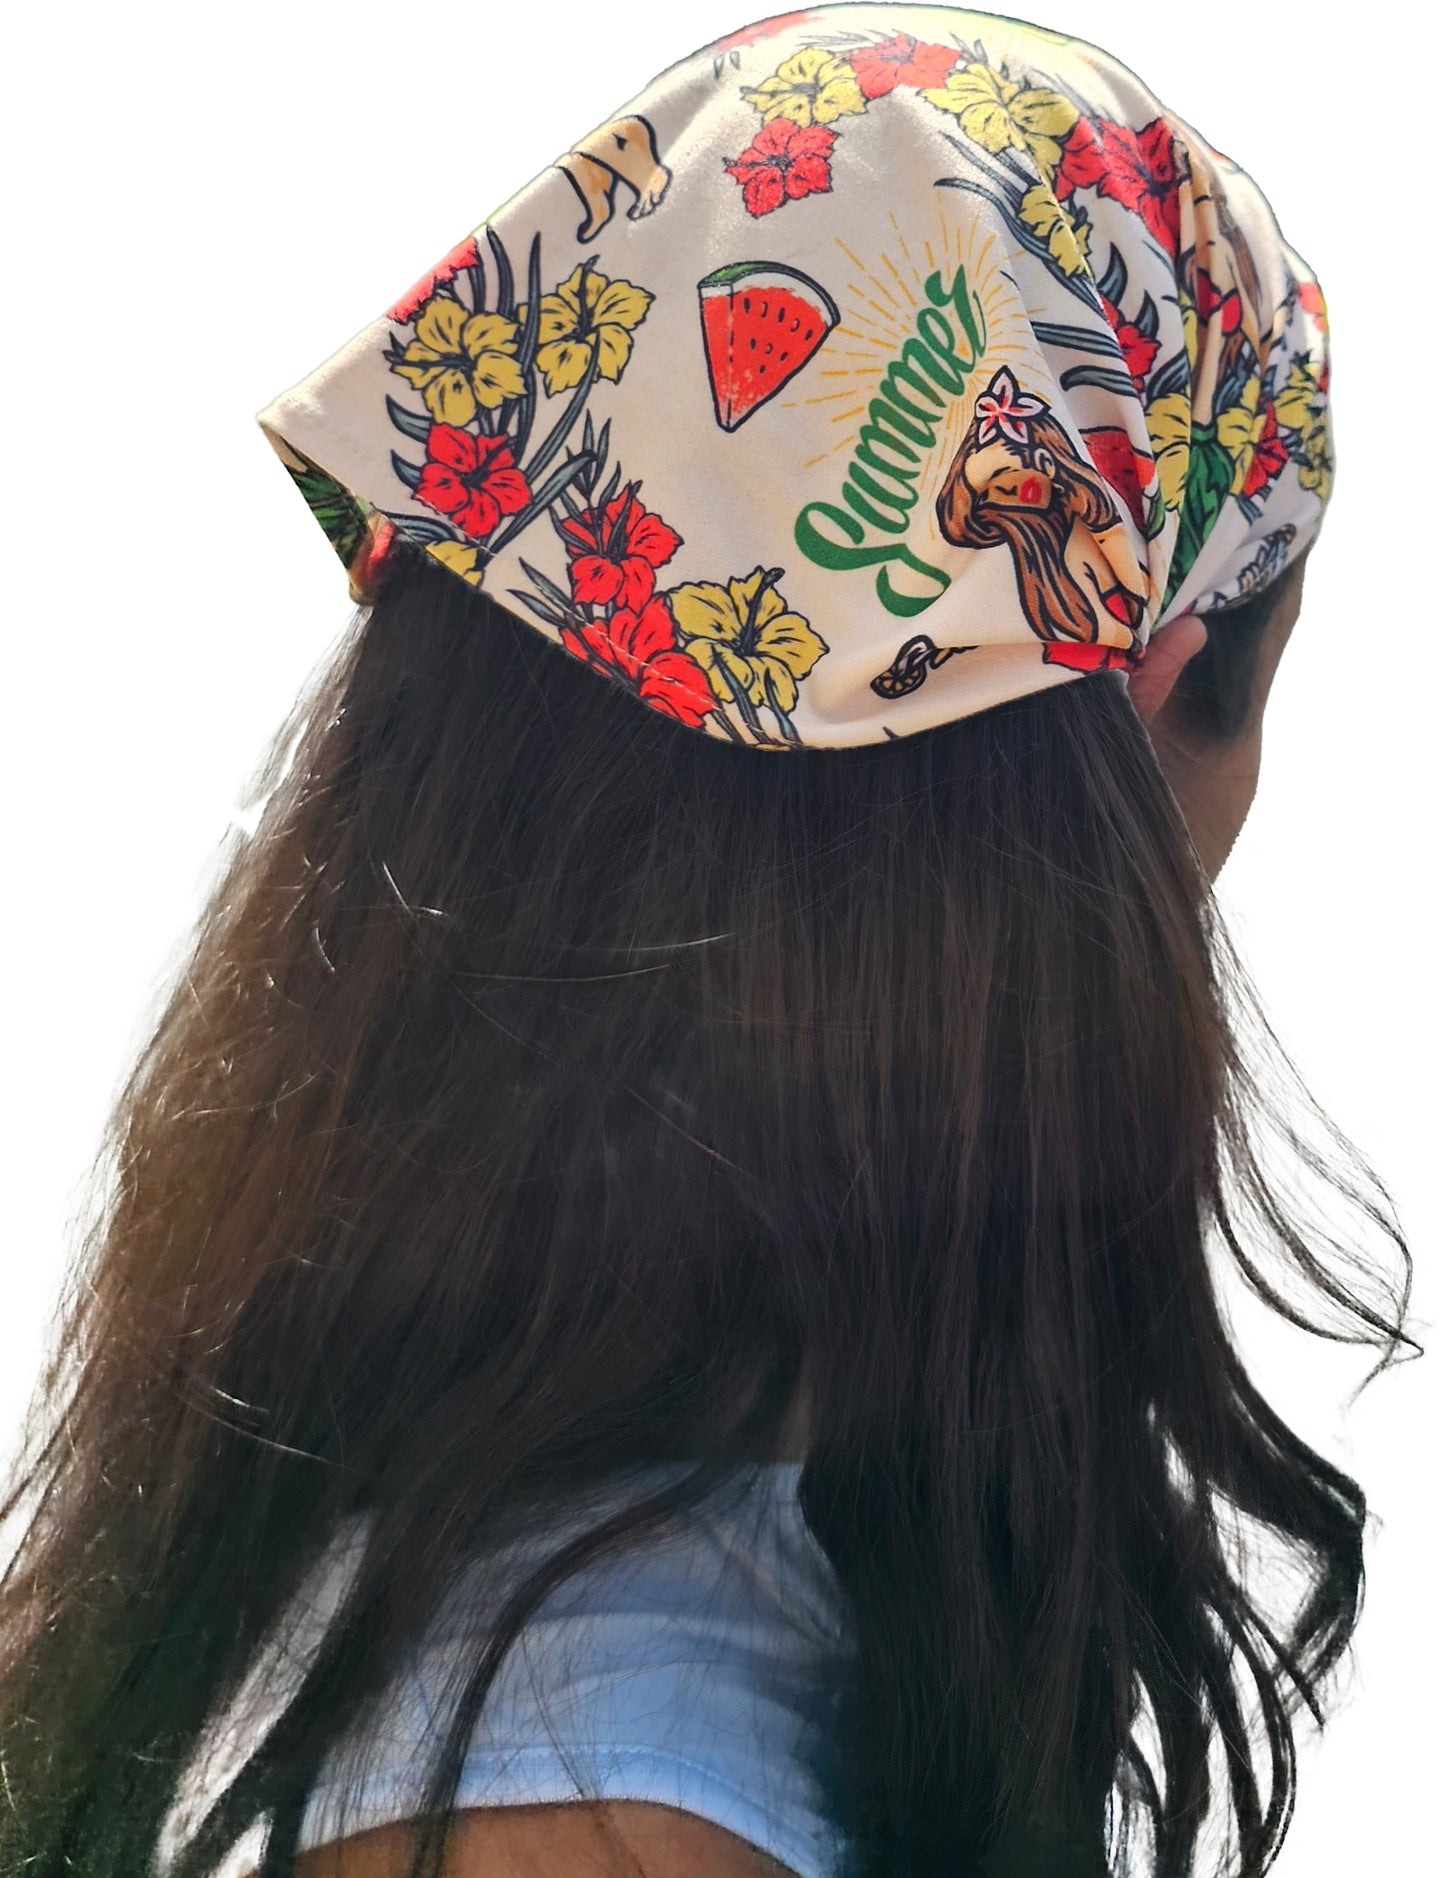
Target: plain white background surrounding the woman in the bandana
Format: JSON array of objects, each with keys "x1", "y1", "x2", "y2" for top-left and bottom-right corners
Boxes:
[{"x1": 0, "y1": 0, "x2": 1443, "y2": 1878}]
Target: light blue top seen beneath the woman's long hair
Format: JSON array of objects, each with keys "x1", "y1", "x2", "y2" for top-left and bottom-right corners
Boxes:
[{"x1": 160, "y1": 1463, "x2": 849, "y2": 1878}]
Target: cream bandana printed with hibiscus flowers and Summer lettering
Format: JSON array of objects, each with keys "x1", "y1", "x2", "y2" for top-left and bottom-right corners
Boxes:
[{"x1": 259, "y1": 4, "x2": 1332, "y2": 749}]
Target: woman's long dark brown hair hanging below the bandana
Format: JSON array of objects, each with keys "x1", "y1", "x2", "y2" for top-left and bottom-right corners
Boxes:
[{"x1": 0, "y1": 548, "x2": 1407, "y2": 1878}]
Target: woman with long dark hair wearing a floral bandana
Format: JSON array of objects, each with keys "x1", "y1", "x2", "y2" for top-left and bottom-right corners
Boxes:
[{"x1": 0, "y1": 6, "x2": 1406, "y2": 1878}]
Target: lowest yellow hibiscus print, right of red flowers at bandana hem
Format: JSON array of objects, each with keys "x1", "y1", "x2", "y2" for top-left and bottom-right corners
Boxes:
[{"x1": 667, "y1": 567, "x2": 829, "y2": 712}]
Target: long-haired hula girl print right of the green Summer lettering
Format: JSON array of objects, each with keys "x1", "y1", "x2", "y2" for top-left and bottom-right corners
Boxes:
[{"x1": 938, "y1": 366, "x2": 1146, "y2": 650}]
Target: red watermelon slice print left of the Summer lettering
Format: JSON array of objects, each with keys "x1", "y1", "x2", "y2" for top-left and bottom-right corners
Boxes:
[{"x1": 697, "y1": 261, "x2": 838, "y2": 430}]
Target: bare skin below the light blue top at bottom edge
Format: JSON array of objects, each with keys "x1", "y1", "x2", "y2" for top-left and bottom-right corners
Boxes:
[{"x1": 281, "y1": 1799, "x2": 793, "y2": 1878}]
